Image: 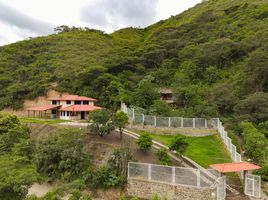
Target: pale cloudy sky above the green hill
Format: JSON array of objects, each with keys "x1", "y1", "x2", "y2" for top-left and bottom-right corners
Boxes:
[{"x1": 0, "y1": 0, "x2": 201, "y2": 46}]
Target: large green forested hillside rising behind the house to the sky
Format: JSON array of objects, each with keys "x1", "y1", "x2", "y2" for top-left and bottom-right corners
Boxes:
[{"x1": 0, "y1": 0, "x2": 268, "y2": 122}]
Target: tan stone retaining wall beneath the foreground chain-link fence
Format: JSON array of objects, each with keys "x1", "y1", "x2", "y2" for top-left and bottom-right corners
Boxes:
[{"x1": 127, "y1": 178, "x2": 217, "y2": 200}]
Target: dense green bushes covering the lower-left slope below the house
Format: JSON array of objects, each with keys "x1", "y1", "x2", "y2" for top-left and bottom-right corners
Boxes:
[{"x1": 0, "y1": 112, "x2": 132, "y2": 200}]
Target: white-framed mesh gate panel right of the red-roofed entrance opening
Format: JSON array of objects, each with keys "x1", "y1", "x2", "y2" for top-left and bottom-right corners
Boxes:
[{"x1": 245, "y1": 174, "x2": 261, "y2": 198}]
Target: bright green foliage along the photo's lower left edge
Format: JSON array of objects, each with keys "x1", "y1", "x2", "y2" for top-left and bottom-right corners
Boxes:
[{"x1": 0, "y1": 113, "x2": 38, "y2": 200}]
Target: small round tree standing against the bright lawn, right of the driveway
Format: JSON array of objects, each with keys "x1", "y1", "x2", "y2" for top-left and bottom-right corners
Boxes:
[{"x1": 168, "y1": 135, "x2": 188, "y2": 156}]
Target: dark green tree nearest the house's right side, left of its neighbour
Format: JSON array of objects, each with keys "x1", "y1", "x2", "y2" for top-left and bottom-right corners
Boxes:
[{"x1": 89, "y1": 109, "x2": 114, "y2": 137}]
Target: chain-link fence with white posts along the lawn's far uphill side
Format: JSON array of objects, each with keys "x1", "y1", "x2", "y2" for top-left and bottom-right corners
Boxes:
[{"x1": 121, "y1": 103, "x2": 218, "y2": 129}]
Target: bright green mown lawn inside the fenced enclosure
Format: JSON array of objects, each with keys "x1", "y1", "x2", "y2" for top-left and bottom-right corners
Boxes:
[{"x1": 139, "y1": 131, "x2": 232, "y2": 168}]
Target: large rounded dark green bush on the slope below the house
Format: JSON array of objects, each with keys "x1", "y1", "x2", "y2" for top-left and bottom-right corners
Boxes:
[{"x1": 35, "y1": 129, "x2": 90, "y2": 181}]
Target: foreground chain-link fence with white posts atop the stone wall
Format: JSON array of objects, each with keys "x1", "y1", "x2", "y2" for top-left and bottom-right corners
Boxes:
[{"x1": 128, "y1": 162, "x2": 220, "y2": 188}]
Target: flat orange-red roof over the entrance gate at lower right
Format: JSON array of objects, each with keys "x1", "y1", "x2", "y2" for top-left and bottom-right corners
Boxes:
[{"x1": 210, "y1": 162, "x2": 261, "y2": 173}]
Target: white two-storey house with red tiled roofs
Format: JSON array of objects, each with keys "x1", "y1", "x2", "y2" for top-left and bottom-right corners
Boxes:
[{"x1": 26, "y1": 95, "x2": 102, "y2": 120}]
